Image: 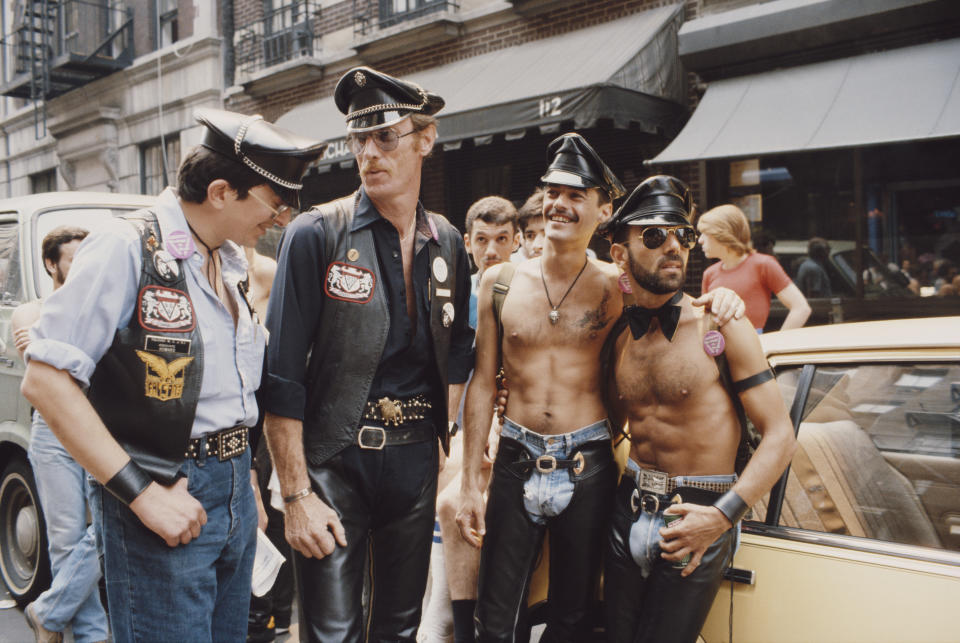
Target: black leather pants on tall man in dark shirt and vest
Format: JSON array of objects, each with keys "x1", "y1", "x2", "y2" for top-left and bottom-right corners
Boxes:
[{"x1": 295, "y1": 440, "x2": 438, "y2": 643}]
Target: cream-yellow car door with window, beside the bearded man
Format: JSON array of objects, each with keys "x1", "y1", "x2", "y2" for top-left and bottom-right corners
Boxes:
[{"x1": 702, "y1": 349, "x2": 960, "y2": 643}]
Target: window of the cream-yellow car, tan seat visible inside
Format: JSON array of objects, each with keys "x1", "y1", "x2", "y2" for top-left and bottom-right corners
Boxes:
[{"x1": 754, "y1": 363, "x2": 960, "y2": 551}]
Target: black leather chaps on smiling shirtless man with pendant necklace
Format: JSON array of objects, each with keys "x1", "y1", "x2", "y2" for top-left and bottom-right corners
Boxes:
[{"x1": 476, "y1": 438, "x2": 616, "y2": 643}]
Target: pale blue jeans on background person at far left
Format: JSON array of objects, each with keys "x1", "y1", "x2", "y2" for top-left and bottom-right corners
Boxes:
[{"x1": 28, "y1": 413, "x2": 107, "y2": 643}]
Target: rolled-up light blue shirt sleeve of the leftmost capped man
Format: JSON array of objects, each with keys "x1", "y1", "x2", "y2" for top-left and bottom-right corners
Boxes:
[{"x1": 24, "y1": 221, "x2": 140, "y2": 386}]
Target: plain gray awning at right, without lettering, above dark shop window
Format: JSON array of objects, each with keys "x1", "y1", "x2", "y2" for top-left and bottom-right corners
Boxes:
[{"x1": 652, "y1": 39, "x2": 960, "y2": 164}]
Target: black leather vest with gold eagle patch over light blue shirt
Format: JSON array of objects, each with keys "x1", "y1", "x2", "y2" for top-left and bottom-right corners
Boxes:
[{"x1": 87, "y1": 210, "x2": 203, "y2": 484}]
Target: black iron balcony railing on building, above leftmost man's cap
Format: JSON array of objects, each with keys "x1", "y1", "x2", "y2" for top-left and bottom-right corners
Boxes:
[{"x1": 235, "y1": 0, "x2": 320, "y2": 74}]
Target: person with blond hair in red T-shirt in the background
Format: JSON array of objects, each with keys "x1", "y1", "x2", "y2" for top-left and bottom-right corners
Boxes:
[{"x1": 697, "y1": 204, "x2": 810, "y2": 331}]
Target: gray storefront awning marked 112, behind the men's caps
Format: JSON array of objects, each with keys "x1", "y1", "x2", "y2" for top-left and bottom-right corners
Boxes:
[{"x1": 277, "y1": 5, "x2": 684, "y2": 165}]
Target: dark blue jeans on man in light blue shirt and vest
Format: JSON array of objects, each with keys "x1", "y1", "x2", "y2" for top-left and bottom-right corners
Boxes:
[{"x1": 94, "y1": 449, "x2": 257, "y2": 643}]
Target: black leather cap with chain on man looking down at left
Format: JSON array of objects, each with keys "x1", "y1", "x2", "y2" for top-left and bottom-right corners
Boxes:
[{"x1": 194, "y1": 108, "x2": 326, "y2": 200}]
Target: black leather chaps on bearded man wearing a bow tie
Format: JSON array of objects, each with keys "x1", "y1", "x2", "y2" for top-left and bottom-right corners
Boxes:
[{"x1": 603, "y1": 476, "x2": 736, "y2": 643}]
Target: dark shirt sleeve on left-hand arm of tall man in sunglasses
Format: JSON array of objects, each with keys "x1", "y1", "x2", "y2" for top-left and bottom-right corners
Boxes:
[{"x1": 264, "y1": 212, "x2": 326, "y2": 421}]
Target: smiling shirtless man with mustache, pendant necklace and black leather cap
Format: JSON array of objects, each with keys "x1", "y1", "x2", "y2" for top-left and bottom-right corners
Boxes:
[{"x1": 458, "y1": 134, "x2": 741, "y2": 641}]
